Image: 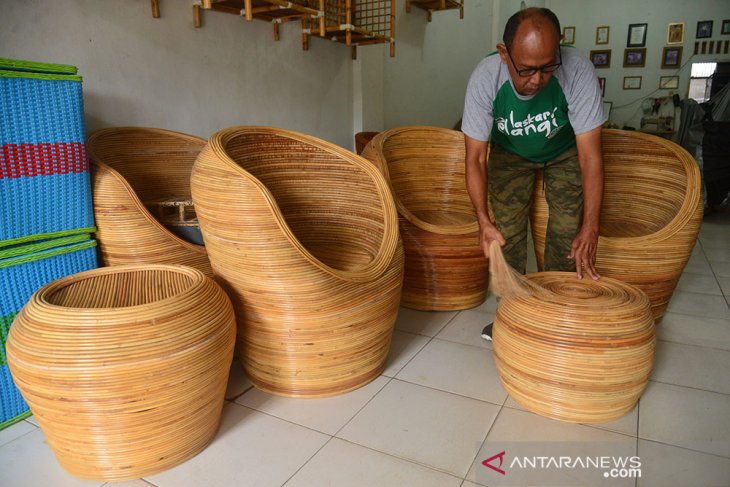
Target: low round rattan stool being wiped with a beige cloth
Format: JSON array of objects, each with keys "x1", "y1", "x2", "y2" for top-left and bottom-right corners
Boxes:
[{"x1": 490, "y1": 243, "x2": 656, "y2": 423}]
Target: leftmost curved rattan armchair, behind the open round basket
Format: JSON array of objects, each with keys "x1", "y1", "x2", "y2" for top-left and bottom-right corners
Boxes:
[{"x1": 87, "y1": 127, "x2": 212, "y2": 275}]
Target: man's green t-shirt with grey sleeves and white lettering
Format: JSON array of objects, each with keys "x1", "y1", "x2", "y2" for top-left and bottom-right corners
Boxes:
[{"x1": 461, "y1": 46, "x2": 606, "y2": 162}]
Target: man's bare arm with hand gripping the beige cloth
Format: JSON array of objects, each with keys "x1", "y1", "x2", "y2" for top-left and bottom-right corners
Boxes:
[{"x1": 464, "y1": 135, "x2": 507, "y2": 258}]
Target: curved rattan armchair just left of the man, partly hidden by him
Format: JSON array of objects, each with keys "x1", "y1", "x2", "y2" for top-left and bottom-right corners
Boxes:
[{"x1": 363, "y1": 126, "x2": 489, "y2": 311}]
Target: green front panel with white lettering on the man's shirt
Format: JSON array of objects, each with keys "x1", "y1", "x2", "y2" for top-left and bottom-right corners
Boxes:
[{"x1": 491, "y1": 77, "x2": 575, "y2": 162}]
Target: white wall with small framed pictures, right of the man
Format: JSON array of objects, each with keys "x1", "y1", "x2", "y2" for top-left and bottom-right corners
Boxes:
[{"x1": 545, "y1": 0, "x2": 730, "y2": 128}]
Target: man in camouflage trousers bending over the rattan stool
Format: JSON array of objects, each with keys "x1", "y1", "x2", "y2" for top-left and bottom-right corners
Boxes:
[{"x1": 462, "y1": 8, "x2": 606, "y2": 340}]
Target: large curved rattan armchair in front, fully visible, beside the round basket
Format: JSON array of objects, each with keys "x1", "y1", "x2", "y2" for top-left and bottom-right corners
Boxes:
[{"x1": 191, "y1": 127, "x2": 403, "y2": 397}]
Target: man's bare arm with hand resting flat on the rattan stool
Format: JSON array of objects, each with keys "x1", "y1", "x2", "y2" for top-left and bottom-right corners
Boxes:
[{"x1": 569, "y1": 127, "x2": 603, "y2": 279}]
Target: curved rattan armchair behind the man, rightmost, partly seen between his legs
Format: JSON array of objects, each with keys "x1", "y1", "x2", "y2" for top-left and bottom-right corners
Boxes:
[{"x1": 531, "y1": 130, "x2": 703, "y2": 320}]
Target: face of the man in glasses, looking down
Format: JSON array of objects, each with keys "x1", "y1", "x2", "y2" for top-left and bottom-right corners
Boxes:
[{"x1": 497, "y1": 19, "x2": 560, "y2": 96}]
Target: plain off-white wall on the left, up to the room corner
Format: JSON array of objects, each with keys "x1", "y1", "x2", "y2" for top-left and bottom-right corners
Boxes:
[{"x1": 0, "y1": 0, "x2": 354, "y2": 148}]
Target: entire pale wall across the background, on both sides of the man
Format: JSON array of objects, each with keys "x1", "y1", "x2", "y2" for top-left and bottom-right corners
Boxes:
[{"x1": 0, "y1": 0, "x2": 730, "y2": 148}]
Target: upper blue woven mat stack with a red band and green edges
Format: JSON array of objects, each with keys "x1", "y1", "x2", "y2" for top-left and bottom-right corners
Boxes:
[{"x1": 0, "y1": 58, "x2": 94, "y2": 247}]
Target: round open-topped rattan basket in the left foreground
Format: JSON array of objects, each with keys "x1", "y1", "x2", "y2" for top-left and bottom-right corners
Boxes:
[{"x1": 7, "y1": 265, "x2": 235, "y2": 481}]
